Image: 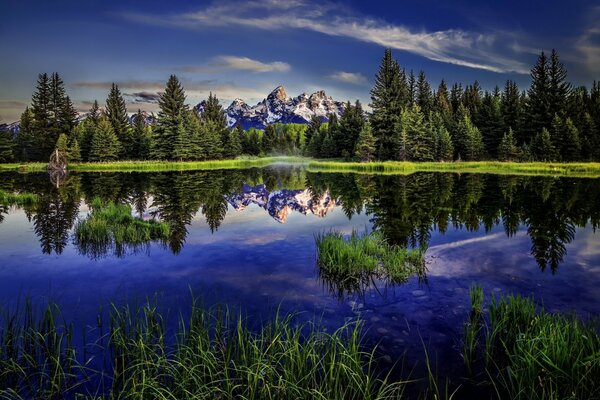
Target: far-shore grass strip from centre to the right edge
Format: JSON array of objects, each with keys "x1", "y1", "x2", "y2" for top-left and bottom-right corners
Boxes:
[{"x1": 308, "y1": 161, "x2": 600, "y2": 178}]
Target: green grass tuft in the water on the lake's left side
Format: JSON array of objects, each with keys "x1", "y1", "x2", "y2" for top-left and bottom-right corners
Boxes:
[{"x1": 75, "y1": 198, "x2": 170, "y2": 257}]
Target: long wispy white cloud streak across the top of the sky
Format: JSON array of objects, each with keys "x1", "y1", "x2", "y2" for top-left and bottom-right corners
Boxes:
[{"x1": 122, "y1": 0, "x2": 529, "y2": 74}]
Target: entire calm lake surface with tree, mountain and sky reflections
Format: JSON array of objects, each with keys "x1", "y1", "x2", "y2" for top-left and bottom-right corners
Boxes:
[{"x1": 0, "y1": 167, "x2": 600, "y2": 380}]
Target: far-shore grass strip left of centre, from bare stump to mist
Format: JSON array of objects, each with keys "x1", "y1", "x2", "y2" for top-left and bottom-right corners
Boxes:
[{"x1": 68, "y1": 157, "x2": 308, "y2": 172}]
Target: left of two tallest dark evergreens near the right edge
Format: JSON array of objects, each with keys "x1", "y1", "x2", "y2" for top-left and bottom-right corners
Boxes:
[{"x1": 523, "y1": 52, "x2": 554, "y2": 141}]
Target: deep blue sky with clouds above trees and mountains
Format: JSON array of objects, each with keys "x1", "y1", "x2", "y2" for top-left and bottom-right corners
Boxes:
[{"x1": 0, "y1": 0, "x2": 600, "y2": 123}]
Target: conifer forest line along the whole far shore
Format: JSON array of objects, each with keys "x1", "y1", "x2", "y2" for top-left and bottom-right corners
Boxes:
[{"x1": 0, "y1": 49, "x2": 600, "y2": 162}]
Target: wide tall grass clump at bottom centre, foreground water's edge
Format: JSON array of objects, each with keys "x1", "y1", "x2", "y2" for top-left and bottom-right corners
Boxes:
[{"x1": 111, "y1": 300, "x2": 403, "y2": 399}]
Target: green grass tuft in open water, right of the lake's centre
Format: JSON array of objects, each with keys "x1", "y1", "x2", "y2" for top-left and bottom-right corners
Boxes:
[{"x1": 315, "y1": 231, "x2": 425, "y2": 295}]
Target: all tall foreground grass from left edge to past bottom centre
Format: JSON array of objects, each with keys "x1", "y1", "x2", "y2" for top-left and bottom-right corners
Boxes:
[{"x1": 0, "y1": 302, "x2": 404, "y2": 399}]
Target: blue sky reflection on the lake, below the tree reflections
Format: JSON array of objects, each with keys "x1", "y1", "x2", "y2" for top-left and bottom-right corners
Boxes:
[{"x1": 0, "y1": 198, "x2": 600, "y2": 382}]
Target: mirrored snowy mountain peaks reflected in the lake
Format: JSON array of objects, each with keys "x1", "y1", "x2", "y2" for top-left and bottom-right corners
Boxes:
[{"x1": 226, "y1": 184, "x2": 340, "y2": 224}]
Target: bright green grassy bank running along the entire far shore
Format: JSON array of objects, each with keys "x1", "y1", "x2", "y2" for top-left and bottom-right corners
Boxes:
[{"x1": 0, "y1": 156, "x2": 600, "y2": 178}]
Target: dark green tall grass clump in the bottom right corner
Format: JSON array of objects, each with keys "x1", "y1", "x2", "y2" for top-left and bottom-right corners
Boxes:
[{"x1": 476, "y1": 290, "x2": 600, "y2": 399}]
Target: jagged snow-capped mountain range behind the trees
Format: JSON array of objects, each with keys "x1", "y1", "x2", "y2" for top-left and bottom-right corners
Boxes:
[{"x1": 194, "y1": 86, "x2": 345, "y2": 129}]
